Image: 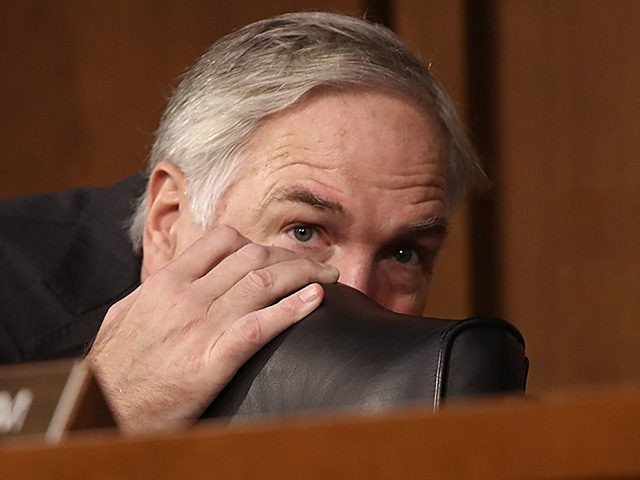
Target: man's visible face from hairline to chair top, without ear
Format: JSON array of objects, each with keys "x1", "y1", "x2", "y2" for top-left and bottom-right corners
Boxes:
[{"x1": 209, "y1": 90, "x2": 448, "y2": 314}]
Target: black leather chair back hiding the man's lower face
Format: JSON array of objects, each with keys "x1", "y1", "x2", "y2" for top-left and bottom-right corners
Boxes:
[{"x1": 203, "y1": 284, "x2": 528, "y2": 419}]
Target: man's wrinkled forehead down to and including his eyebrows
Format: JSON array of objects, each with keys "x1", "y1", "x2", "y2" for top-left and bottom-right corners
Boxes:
[{"x1": 219, "y1": 86, "x2": 449, "y2": 238}]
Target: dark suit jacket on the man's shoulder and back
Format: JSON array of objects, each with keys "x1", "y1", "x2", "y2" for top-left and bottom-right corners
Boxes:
[{"x1": 0, "y1": 175, "x2": 145, "y2": 363}]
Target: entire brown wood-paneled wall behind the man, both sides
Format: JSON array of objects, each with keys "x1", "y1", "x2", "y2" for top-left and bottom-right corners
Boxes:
[{"x1": 0, "y1": 0, "x2": 640, "y2": 391}]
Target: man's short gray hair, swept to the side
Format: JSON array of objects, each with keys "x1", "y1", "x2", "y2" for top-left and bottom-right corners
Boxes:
[{"x1": 130, "y1": 12, "x2": 482, "y2": 249}]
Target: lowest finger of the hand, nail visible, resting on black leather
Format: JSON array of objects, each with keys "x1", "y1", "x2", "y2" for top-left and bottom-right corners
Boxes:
[{"x1": 209, "y1": 283, "x2": 324, "y2": 388}]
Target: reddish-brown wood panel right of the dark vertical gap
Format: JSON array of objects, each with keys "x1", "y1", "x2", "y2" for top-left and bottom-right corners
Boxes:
[{"x1": 497, "y1": 0, "x2": 640, "y2": 386}]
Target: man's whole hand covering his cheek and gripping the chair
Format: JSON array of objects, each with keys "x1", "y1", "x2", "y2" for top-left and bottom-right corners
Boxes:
[{"x1": 87, "y1": 226, "x2": 338, "y2": 432}]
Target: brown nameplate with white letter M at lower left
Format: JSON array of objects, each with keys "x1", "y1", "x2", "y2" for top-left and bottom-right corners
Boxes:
[{"x1": 0, "y1": 360, "x2": 115, "y2": 442}]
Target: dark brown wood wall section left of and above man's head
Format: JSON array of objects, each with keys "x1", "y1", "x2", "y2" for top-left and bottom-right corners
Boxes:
[{"x1": 0, "y1": 0, "x2": 362, "y2": 198}]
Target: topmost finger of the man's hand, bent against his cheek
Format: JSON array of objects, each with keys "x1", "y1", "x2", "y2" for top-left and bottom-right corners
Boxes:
[{"x1": 163, "y1": 225, "x2": 250, "y2": 281}]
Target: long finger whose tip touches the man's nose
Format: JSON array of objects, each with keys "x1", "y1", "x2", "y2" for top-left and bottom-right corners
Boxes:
[{"x1": 207, "y1": 258, "x2": 339, "y2": 322}]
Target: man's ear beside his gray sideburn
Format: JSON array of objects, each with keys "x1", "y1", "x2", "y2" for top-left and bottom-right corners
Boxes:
[{"x1": 142, "y1": 162, "x2": 190, "y2": 278}]
